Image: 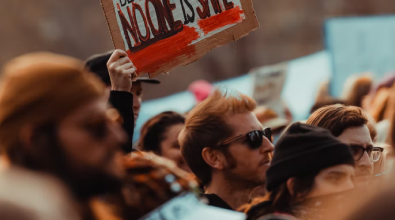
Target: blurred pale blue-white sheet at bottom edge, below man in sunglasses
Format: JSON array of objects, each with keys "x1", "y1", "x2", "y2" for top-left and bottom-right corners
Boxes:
[{"x1": 140, "y1": 193, "x2": 246, "y2": 220}]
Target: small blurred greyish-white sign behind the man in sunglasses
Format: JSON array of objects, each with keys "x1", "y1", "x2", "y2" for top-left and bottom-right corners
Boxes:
[{"x1": 250, "y1": 63, "x2": 288, "y2": 117}]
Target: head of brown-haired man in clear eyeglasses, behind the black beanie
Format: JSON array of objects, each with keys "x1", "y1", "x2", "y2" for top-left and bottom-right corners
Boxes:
[{"x1": 306, "y1": 104, "x2": 383, "y2": 189}]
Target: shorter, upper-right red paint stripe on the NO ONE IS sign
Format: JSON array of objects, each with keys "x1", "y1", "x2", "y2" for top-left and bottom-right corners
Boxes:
[{"x1": 198, "y1": 6, "x2": 244, "y2": 34}]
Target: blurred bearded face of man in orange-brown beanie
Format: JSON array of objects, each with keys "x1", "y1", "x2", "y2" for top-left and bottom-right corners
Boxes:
[{"x1": 57, "y1": 99, "x2": 126, "y2": 197}]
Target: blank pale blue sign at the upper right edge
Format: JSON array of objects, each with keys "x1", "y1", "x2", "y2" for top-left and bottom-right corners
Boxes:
[{"x1": 325, "y1": 15, "x2": 395, "y2": 97}]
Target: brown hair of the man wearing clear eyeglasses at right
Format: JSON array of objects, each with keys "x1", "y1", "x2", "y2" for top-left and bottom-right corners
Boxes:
[{"x1": 306, "y1": 104, "x2": 377, "y2": 141}]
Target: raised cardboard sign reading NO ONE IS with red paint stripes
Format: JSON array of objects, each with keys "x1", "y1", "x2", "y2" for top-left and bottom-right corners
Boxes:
[{"x1": 101, "y1": 0, "x2": 259, "y2": 77}]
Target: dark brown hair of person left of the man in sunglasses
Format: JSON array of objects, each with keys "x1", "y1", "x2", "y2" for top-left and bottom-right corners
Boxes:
[{"x1": 137, "y1": 111, "x2": 185, "y2": 155}]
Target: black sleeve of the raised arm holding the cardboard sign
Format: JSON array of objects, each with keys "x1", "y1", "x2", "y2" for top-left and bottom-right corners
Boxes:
[{"x1": 109, "y1": 91, "x2": 134, "y2": 153}]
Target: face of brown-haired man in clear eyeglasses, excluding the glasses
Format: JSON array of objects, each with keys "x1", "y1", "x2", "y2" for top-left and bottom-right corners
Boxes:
[{"x1": 338, "y1": 125, "x2": 373, "y2": 188}]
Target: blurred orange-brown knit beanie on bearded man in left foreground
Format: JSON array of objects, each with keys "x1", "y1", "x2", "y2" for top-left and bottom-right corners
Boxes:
[{"x1": 0, "y1": 52, "x2": 105, "y2": 149}]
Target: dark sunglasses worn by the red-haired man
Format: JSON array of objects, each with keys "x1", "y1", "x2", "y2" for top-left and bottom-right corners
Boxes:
[{"x1": 219, "y1": 128, "x2": 272, "y2": 149}]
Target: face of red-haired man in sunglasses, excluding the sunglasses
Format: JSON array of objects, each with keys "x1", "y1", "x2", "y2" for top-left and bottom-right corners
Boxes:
[{"x1": 224, "y1": 112, "x2": 274, "y2": 188}]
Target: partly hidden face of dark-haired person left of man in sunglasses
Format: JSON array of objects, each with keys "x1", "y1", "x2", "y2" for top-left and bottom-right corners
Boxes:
[{"x1": 160, "y1": 123, "x2": 191, "y2": 172}]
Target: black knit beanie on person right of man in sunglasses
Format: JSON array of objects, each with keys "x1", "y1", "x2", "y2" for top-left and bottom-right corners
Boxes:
[{"x1": 266, "y1": 122, "x2": 355, "y2": 191}]
